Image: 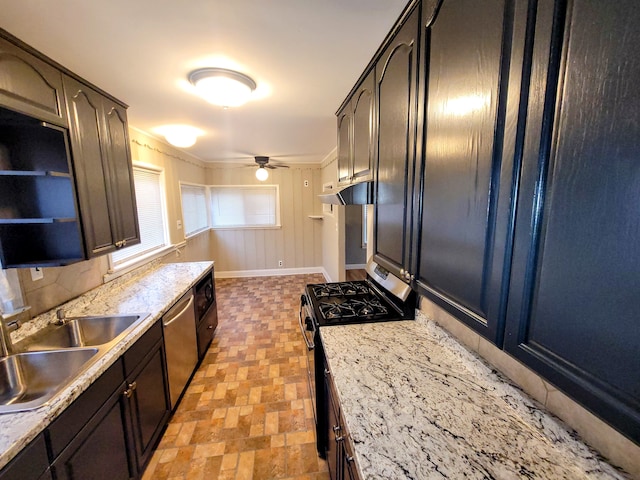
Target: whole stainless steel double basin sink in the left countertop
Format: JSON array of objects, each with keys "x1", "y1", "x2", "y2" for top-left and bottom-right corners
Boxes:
[{"x1": 0, "y1": 314, "x2": 147, "y2": 413}]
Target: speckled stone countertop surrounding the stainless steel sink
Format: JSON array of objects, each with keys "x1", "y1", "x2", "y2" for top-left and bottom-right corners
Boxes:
[{"x1": 0, "y1": 262, "x2": 213, "y2": 468}]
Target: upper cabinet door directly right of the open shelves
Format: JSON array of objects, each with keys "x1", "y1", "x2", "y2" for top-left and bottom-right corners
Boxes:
[{"x1": 64, "y1": 77, "x2": 119, "y2": 257}]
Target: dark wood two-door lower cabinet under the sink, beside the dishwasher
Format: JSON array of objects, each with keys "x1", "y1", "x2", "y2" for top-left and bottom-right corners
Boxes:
[{"x1": 47, "y1": 323, "x2": 170, "y2": 480}]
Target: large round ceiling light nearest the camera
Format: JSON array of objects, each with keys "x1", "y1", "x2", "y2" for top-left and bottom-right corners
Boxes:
[{"x1": 189, "y1": 68, "x2": 256, "y2": 107}]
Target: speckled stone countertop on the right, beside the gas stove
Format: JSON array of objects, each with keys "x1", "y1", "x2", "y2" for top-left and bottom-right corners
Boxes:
[{"x1": 320, "y1": 313, "x2": 628, "y2": 480}]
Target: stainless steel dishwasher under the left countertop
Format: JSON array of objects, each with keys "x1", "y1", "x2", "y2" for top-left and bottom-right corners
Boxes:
[{"x1": 162, "y1": 290, "x2": 198, "y2": 410}]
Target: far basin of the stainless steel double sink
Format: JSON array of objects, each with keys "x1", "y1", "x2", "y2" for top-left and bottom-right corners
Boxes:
[{"x1": 16, "y1": 315, "x2": 143, "y2": 352}]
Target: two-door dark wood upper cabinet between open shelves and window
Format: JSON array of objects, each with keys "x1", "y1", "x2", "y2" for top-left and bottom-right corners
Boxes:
[{"x1": 64, "y1": 76, "x2": 140, "y2": 257}]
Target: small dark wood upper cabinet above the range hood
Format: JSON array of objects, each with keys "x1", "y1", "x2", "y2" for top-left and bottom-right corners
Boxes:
[{"x1": 337, "y1": 70, "x2": 375, "y2": 184}]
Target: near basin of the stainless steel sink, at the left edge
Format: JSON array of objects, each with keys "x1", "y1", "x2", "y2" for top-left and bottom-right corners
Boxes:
[{"x1": 0, "y1": 348, "x2": 98, "y2": 413}]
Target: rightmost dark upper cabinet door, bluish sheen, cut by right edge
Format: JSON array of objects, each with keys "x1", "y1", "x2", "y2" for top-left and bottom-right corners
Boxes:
[{"x1": 505, "y1": 0, "x2": 640, "y2": 442}]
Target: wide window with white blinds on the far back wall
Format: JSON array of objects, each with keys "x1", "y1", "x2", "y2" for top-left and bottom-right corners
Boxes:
[{"x1": 209, "y1": 185, "x2": 280, "y2": 228}]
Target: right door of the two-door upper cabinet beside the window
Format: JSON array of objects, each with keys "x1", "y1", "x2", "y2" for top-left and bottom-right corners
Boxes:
[{"x1": 103, "y1": 99, "x2": 140, "y2": 249}]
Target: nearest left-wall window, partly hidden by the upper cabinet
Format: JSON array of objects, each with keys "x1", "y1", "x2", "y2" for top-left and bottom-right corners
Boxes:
[{"x1": 111, "y1": 166, "x2": 167, "y2": 267}]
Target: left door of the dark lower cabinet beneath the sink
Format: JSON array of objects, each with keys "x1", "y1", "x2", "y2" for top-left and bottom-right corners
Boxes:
[{"x1": 51, "y1": 384, "x2": 136, "y2": 480}]
